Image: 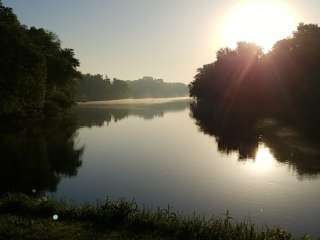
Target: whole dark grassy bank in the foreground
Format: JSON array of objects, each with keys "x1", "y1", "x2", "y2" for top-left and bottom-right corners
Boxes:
[{"x1": 0, "y1": 195, "x2": 310, "y2": 240}]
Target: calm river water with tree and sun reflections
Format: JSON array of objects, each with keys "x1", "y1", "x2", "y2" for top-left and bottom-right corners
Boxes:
[{"x1": 0, "y1": 100, "x2": 320, "y2": 236}]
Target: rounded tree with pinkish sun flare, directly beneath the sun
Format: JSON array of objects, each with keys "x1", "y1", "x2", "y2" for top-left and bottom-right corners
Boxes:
[{"x1": 189, "y1": 42, "x2": 263, "y2": 114}]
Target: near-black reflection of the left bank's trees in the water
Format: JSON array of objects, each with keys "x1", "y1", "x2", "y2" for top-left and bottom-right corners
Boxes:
[{"x1": 0, "y1": 116, "x2": 83, "y2": 193}]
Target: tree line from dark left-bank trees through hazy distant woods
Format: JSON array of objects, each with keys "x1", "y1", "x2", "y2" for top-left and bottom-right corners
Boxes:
[{"x1": 0, "y1": 0, "x2": 188, "y2": 117}]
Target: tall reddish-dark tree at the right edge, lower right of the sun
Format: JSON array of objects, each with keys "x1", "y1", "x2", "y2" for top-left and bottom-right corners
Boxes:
[{"x1": 266, "y1": 23, "x2": 320, "y2": 120}]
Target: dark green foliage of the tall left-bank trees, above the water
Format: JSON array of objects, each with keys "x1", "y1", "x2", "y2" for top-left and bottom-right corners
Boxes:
[{"x1": 0, "y1": 2, "x2": 79, "y2": 116}]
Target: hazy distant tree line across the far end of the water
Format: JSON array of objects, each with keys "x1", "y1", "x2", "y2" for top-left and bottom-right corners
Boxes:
[{"x1": 76, "y1": 74, "x2": 188, "y2": 101}]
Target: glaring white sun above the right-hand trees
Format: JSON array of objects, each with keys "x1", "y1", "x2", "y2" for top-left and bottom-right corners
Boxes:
[{"x1": 224, "y1": 0, "x2": 297, "y2": 52}]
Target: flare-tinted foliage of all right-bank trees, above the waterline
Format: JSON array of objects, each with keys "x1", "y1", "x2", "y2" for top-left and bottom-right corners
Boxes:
[{"x1": 189, "y1": 24, "x2": 320, "y2": 118}]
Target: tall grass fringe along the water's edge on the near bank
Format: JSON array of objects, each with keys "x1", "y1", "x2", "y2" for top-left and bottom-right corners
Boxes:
[{"x1": 0, "y1": 194, "x2": 311, "y2": 240}]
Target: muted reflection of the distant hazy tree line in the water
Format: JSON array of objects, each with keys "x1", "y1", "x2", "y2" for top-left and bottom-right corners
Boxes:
[{"x1": 75, "y1": 100, "x2": 189, "y2": 127}]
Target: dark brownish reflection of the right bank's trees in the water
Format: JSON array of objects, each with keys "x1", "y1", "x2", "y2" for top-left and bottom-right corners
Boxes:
[{"x1": 191, "y1": 103, "x2": 320, "y2": 178}]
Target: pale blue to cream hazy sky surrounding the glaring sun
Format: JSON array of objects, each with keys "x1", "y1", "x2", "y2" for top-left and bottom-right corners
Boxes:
[{"x1": 3, "y1": 0, "x2": 320, "y2": 83}]
